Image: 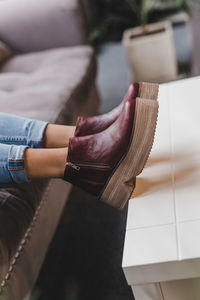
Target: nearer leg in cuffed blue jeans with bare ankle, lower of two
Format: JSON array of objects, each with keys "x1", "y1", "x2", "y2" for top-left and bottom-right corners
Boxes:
[{"x1": 0, "y1": 144, "x2": 68, "y2": 183}]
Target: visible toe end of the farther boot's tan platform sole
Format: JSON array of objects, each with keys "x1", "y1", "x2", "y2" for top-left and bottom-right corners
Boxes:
[{"x1": 139, "y1": 82, "x2": 159, "y2": 100}]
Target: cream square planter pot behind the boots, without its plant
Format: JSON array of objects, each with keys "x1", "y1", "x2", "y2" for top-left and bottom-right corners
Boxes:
[{"x1": 122, "y1": 22, "x2": 177, "y2": 82}]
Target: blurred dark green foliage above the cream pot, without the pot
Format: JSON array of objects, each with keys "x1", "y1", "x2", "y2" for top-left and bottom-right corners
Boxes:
[{"x1": 90, "y1": 0, "x2": 196, "y2": 46}]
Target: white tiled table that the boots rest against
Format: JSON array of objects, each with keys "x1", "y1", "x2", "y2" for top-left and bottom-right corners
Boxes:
[{"x1": 122, "y1": 77, "x2": 200, "y2": 300}]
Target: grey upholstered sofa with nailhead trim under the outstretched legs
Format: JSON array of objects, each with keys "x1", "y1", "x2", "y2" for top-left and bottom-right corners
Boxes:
[{"x1": 0, "y1": 0, "x2": 99, "y2": 300}]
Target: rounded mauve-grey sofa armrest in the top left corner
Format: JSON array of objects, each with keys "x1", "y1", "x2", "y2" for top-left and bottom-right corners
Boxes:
[{"x1": 0, "y1": 0, "x2": 87, "y2": 52}]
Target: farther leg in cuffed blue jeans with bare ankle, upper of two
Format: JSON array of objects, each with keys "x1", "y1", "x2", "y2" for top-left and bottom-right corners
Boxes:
[{"x1": 0, "y1": 113, "x2": 75, "y2": 148}]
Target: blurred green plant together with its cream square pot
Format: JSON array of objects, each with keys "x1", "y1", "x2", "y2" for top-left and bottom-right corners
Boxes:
[{"x1": 90, "y1": 0, "x2": 197, "y2": 81}]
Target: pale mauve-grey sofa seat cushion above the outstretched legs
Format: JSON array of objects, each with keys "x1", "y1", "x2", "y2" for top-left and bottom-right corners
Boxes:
[{"x1": 0, "y1": 46, "x2": 94, "y2": 123}]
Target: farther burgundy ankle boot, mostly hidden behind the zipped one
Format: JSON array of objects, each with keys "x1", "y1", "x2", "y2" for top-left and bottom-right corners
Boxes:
[{"x1": 74, "y1": 82, "x2": 158, "y2": 136}]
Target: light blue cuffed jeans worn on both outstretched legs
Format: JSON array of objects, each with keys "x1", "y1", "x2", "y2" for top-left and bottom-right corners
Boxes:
[{"x1": 0, "y1": 113, "x2": 48, "y2": 183}]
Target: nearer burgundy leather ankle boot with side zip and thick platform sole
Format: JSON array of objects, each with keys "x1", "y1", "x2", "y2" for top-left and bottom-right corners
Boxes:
[{"x1": 63, "y1": 85, "x2": 158, "y2": 209}]
